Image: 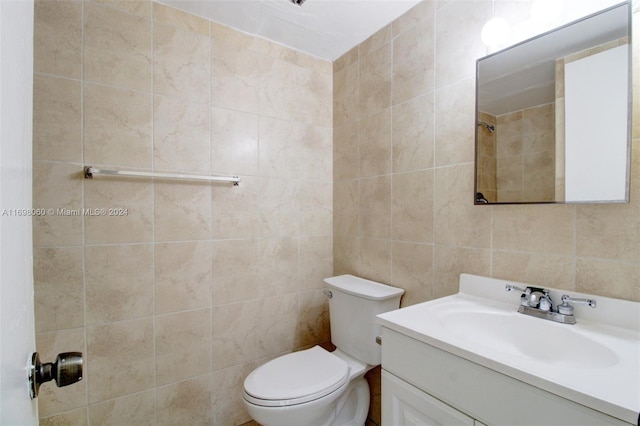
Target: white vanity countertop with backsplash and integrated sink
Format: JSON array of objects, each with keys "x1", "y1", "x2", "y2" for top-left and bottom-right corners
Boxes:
[{"x1": 378, "y1": 274, "x2": 640, "y2": 424}]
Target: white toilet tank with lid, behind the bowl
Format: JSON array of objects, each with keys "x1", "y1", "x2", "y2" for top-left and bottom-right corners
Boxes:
[{"x1": 324, "y1": 275, "x2": 404, "y2": 365}]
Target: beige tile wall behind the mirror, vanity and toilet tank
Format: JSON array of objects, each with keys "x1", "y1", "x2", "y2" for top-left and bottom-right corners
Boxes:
[{"x1": 333, "y1": 0, "x2": 640, "y2": 420}]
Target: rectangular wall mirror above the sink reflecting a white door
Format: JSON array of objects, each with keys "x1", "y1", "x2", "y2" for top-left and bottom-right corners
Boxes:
[{"x1": 475, "y1": 2, "x2": 632, "y2": 204}]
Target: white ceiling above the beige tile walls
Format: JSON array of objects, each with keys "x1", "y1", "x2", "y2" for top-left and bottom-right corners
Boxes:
[{"x1": 157, "y1": 0, "x2": 420, "y2": 61}]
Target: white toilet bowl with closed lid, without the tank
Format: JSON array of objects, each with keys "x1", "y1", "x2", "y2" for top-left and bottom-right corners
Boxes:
[{"x1": 243, "y1": 346, "x2": 372, "y2": 426}]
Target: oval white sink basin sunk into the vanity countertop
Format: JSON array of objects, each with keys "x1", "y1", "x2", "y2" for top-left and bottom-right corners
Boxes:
[{"x1": 438, "y1": 311, "x2": 619, "y2": 368}]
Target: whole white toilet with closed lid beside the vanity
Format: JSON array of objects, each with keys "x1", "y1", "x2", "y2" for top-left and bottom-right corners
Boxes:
[{"x1": 243, "y1": 275, "x2": 404, "y2": 426}]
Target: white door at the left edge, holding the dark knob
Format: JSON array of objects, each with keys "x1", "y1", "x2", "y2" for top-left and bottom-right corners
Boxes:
[{"x1": 0, "y1": 0, "x2": 38, "y2": 426}]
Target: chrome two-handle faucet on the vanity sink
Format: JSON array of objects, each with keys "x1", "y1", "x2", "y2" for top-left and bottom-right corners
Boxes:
[{"x1": 504, "y1": 284, "x2": 596, "y2": 324}]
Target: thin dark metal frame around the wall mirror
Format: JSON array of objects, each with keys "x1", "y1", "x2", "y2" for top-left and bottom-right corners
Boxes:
[{"x1": 474, "y1": 0, "x2": 633, "y2": 205}]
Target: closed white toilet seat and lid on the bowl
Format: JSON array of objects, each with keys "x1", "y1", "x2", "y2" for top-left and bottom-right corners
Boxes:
[{"x1": 244, "y1": 346, "x2": 349, "y2": 407}]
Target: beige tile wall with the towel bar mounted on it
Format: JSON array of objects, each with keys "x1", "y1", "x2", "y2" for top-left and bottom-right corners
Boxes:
[{"x1": 34, "y1": 0, "x2": 333, "y2": 425}]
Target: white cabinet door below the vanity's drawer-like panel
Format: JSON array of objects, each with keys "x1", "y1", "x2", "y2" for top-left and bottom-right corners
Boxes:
[{"x1": 382, "y1": 370, "x2": 474, "y2": 426}]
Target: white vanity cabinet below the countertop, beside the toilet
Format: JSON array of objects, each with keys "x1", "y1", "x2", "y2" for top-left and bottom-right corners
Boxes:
[{"x1": 382, "y1": 326, "x2": 630, "y2": 426}]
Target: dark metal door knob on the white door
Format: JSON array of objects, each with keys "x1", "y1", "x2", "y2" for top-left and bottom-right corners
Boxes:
[{"x1": 29, "y1": 352, "x2": 82, "y2": 399}]
